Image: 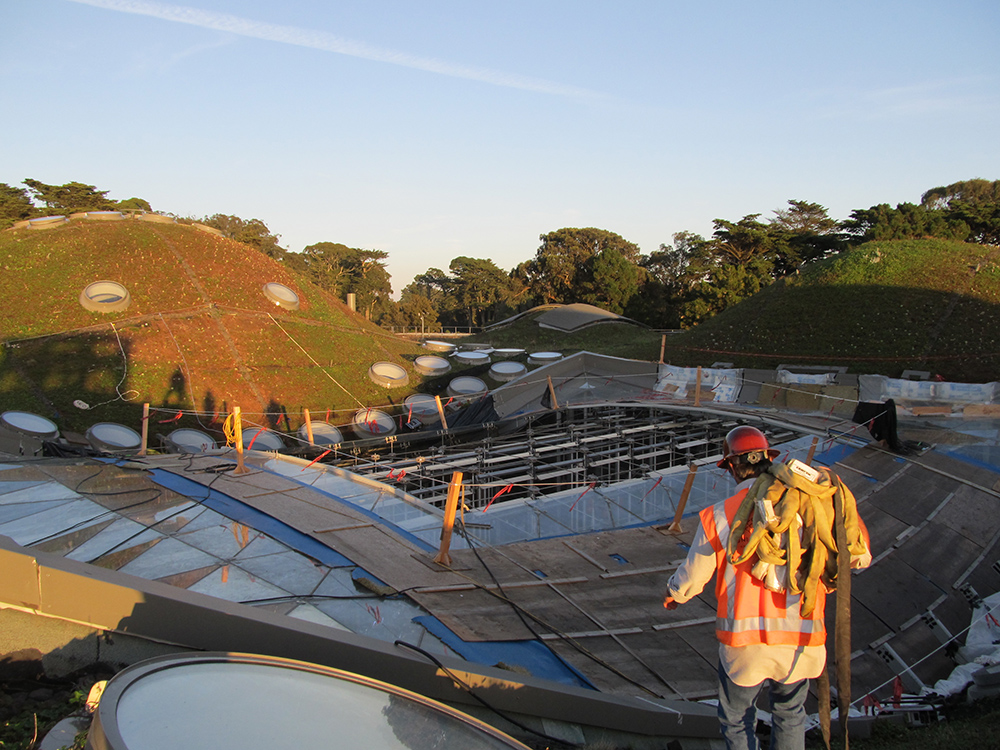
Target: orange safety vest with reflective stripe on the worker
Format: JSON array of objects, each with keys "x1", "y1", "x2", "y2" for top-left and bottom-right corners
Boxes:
[{"x1": 699, "y1": 488, "x2": 827, "y2": 646}]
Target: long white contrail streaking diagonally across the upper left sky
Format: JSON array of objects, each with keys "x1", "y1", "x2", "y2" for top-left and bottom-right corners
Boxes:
[{"x1": 69, "y1": 0, "x2": 600, "y2": 98}]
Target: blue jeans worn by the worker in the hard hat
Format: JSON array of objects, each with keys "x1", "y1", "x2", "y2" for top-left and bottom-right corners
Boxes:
[{"x1": 719, "y1": 664, "x2": 809, "y2": 750}]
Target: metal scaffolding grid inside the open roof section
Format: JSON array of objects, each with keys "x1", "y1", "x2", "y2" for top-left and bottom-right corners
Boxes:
[{"x1": 336, "y1": 403, "x2": 796, "y2": 509}]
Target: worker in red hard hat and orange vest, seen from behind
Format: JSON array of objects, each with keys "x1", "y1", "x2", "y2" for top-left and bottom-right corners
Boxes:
[{"x1": 663, "y1": 426, "x2": 871, "y2": 750}]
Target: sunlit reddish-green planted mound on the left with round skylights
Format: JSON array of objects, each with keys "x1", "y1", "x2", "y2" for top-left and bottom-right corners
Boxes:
[{"x1": 0, "y1": 219, "x2": 420, "y2": 430}]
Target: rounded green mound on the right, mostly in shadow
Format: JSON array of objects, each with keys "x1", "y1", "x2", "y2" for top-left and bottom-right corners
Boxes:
[{"x1": 665, "y1": 240, "x2": 1000, "y2": 382}]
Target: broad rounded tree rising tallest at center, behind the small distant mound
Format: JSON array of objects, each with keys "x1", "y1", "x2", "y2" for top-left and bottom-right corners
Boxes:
[{"x1": 522, "y1": 227, "x2": 641, "y2": 303}]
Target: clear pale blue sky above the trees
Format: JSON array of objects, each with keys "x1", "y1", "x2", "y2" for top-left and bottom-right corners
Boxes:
[{"x1": 0, "y1": 0, "x2": 1000, "y2": 295}]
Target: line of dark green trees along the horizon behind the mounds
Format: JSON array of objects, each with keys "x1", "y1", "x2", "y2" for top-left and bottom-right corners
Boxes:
[{"x1": 0, "y1": 179, "x2": 1000, "y2": 331}]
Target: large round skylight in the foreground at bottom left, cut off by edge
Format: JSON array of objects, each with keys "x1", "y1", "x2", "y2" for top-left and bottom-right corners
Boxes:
[{"x1": 87, "y1": 652, "x2": 527, "y2": 750}]
